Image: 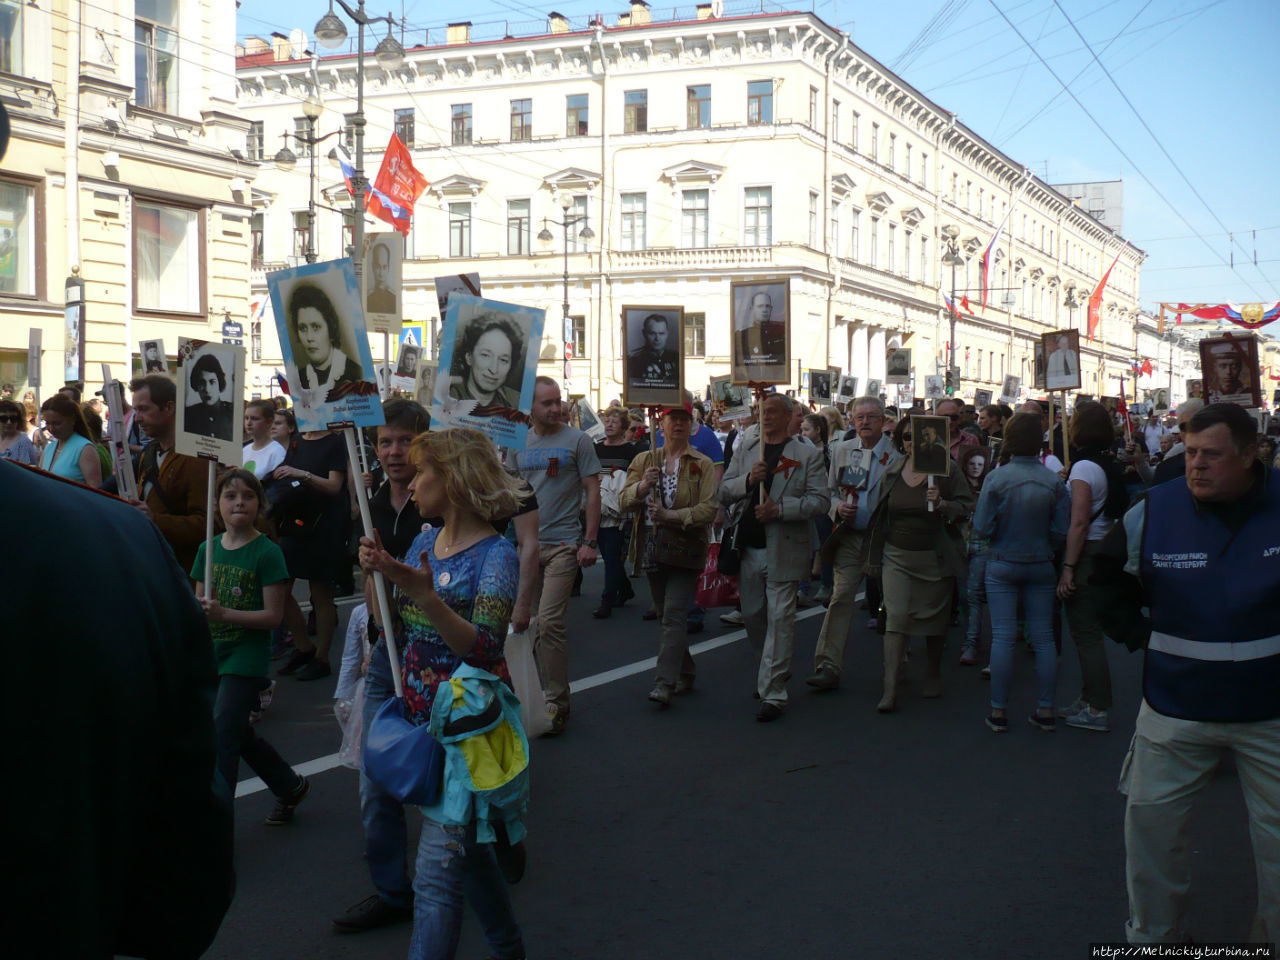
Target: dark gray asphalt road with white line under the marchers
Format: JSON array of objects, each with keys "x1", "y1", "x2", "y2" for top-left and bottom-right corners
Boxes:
[{"x1": 209, "y1": 570, "x2": 1256, "y2": 960}]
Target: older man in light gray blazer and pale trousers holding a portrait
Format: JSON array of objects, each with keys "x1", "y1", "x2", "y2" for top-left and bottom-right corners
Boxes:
[{"x1": 719, "y1": 393, "x2": 831, "y2": 723}]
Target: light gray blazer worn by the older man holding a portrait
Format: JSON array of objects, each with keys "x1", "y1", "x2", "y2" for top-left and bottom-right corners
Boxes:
[{"x1": 717, "y1": 434, "x2": 831, "y2": 580}]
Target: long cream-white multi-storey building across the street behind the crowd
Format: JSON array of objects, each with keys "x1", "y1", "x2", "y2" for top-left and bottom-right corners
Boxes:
[{"x1": 237, "y1": 3, "x2": 1146, "y2": 402}]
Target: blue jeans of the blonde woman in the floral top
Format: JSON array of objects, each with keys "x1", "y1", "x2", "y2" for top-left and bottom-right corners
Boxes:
[{"x1": 408, "y1": 819, "x2": 525, "y2": 960}]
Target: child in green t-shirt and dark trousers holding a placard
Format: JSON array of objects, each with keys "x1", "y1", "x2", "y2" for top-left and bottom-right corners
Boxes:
[{"x1": 191, "y1": 470, "x2": 311, "y2": 826}]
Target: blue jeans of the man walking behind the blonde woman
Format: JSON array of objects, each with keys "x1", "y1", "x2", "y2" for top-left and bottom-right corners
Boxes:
[{"x1": 360, "y1": 644, "x2": 412, "y2": 906}]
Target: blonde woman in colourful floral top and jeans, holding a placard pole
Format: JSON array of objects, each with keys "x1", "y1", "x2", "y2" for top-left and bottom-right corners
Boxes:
[{"x1": 360, "y1": 429, "x2": 525, "y2": 960}]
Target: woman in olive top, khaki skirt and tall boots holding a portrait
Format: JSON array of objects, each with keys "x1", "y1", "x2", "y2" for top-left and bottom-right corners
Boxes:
[{"x1": 867, "y1": 416, "x2": 974, "y2": 713}]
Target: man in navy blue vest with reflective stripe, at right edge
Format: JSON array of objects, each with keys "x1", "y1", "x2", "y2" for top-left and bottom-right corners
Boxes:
[{"x1": 1120, "y1": 403, "x2": 1280, "y2": 943}]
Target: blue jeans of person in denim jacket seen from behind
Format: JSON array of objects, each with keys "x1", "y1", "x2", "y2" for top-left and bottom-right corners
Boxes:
[{"x1": 987, "y1": 559, "x2": 1057, "y2": 710}]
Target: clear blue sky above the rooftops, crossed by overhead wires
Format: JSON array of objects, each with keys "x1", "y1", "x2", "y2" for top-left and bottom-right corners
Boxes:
[{"x1": 238, "y1": 0, "x2": 1280, "y2": 307}]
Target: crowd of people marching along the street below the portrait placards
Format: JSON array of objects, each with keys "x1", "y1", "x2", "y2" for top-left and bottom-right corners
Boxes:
[{"x1": 0, "y1": 374, "x2": 1280, "y2": 959}]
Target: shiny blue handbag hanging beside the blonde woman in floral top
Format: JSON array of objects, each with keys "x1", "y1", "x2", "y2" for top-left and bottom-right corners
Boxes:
[{"x1": 364, "y1": 701, "x2": 447, "y2": 806}]
